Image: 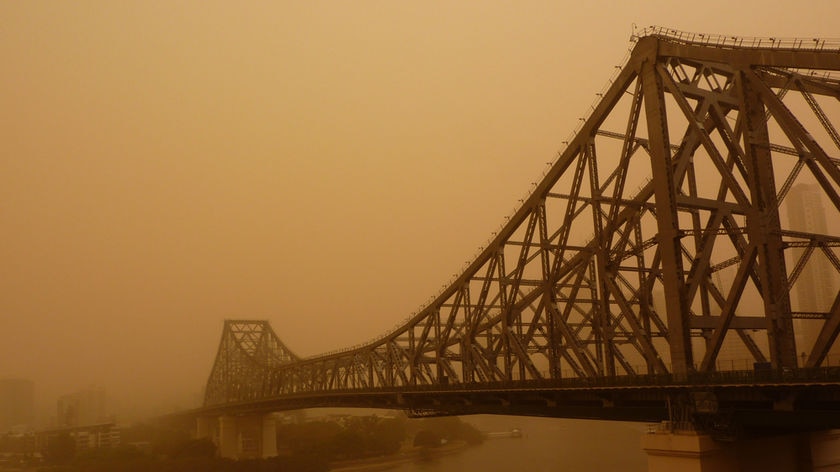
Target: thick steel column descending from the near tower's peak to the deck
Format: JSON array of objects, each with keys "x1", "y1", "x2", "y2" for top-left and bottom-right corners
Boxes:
[{"x1": 640, "y1": 52, "x2": 694, "y2": 377}]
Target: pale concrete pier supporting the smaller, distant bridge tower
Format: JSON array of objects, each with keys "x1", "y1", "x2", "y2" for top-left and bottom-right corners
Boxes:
[{"x1": 195, "y1": 414, "x2": 277, "y2": 459}]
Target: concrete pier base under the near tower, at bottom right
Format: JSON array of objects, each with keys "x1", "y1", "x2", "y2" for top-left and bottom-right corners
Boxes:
[{"x1": 642, "y1": 430, "x2": 840, "y2": 472}]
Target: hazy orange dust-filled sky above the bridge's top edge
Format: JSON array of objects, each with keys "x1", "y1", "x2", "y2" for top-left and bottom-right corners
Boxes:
[{"x1": 0, "y1": 0, "x2": 840, "y2": 420}]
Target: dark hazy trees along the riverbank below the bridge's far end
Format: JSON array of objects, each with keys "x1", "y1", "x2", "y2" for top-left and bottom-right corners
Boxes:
[{"x1": 9, "y1": 412, "x2": 486, "y2": 472}]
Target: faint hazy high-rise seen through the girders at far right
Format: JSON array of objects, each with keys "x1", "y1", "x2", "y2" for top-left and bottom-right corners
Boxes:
[{"x1": 786, "y1": 184, "x2": 837, "y2": 363}]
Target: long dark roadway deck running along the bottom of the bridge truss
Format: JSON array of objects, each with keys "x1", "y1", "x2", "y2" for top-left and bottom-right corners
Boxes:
[{"x1": 186, "y1": 367, "x2": 840, "y2": 436}]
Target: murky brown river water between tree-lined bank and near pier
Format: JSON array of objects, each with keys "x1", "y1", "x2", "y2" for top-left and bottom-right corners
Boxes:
[{"x1": 391, "y1": 415, "x2": 647, "y2": 472}]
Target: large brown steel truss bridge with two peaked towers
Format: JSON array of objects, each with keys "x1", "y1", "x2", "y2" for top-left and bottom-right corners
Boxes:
[{"x1": 201, "y1": 27, "x2": 840, "y2": 436}]
